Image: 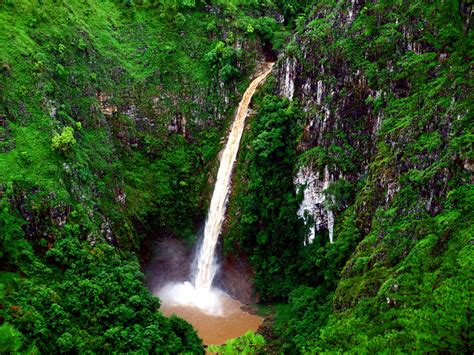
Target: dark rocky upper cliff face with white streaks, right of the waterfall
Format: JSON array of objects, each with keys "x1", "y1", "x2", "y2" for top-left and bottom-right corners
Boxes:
[{"x1": 277, "y1": 1, "x2": 472, "y2": 245}]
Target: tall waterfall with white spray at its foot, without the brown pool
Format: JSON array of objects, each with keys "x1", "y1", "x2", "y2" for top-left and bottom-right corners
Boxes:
[{"x1": 158, "y1": 63, "x2": 273, "y2": 315}]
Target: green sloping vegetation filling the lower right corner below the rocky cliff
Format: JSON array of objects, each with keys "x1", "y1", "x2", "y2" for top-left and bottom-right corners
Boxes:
[{"x1": 312, "y1": 191, "x2": 473, "y2": 352}]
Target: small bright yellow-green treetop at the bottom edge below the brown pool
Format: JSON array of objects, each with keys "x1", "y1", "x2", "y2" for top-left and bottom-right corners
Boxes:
[{"x1": 209, "y1": 331, "x2": 265, "y2": 355}]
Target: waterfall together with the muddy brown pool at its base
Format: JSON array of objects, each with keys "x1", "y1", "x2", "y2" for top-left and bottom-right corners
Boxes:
[{"x1": 150, "y1": 63, "x2": 273, "y2": 344}]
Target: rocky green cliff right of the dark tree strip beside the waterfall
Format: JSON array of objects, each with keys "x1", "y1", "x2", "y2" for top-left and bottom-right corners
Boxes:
[{"x1": 268, "y1": 0, "x2": 474, "y2": 351}]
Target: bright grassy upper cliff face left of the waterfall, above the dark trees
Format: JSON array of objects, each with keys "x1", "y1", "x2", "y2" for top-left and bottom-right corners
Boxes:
[{"x1": 0, "y1": 1, "x2": 262, "y2": 249}]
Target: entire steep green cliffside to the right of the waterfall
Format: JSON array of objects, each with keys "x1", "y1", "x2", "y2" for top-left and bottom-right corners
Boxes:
[{"x1": 228, "y1": 0, "x2": 474, "y2": 352}]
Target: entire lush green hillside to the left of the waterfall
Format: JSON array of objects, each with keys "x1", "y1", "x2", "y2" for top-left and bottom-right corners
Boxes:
[{"x1": 0, "y1": 0, "x2": 293, "y2": 353}]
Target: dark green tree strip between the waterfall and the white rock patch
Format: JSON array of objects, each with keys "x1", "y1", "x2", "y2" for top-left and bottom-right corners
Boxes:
[{"x1": 226, "y1": 95, "x2": 303, "y2": 299}]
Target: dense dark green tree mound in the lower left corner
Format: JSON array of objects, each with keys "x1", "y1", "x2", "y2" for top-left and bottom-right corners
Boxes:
[{"x1": 1, "y1": 232, "x2": 202, "y2": 353}]
